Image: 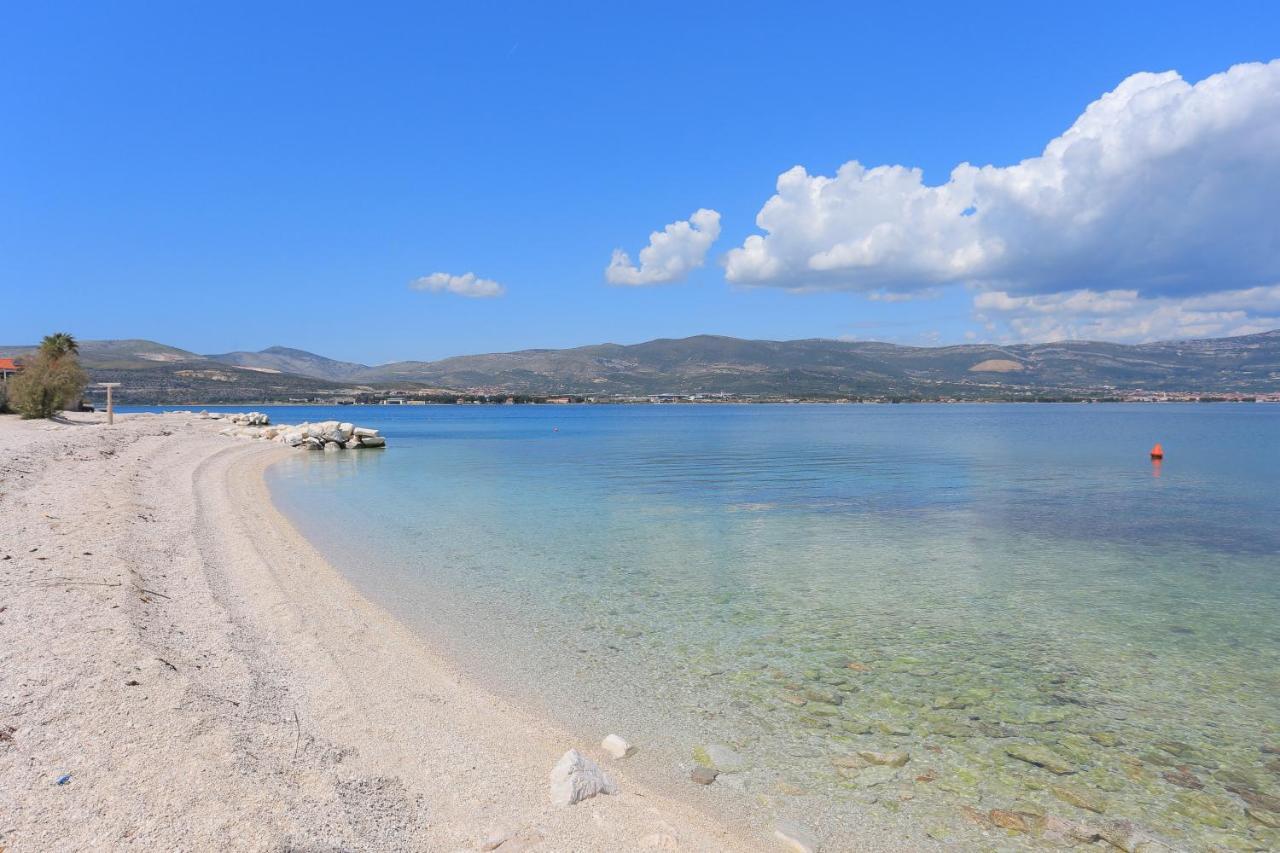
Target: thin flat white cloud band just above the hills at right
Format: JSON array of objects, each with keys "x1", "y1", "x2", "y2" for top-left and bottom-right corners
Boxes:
[{"x1": 974, "y1": 284, "x2": 1280, "y2": 343}]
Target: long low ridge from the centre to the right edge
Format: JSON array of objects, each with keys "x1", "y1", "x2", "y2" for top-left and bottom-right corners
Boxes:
[{"x1": 357, "y1": 330, "x2": 1280, "y2": 396}]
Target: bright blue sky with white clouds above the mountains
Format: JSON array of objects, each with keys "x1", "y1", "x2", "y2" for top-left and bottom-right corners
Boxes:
[{"x1": 0, "y1": 0, "x2": 1280, "y2": 364}]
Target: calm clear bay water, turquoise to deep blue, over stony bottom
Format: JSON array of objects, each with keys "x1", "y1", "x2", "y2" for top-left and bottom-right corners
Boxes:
[{"x1": 149, "y1": 405, "x2": 1280, "y2": 849}]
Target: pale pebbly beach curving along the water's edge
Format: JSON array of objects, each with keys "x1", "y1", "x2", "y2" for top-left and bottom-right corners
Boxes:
[{"x1": 0, "y1": 415, "x2": 762, "y2": 853}]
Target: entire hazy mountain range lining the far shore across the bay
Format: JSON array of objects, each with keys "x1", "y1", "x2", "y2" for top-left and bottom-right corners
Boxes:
[{"x1": 0, "y1": 330, "x2": 1280, "y2": 405}]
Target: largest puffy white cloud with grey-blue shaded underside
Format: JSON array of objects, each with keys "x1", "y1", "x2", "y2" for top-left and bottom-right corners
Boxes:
[{"x1": 724, "y1": 60, "x2": 1280, "y2": 300}]
